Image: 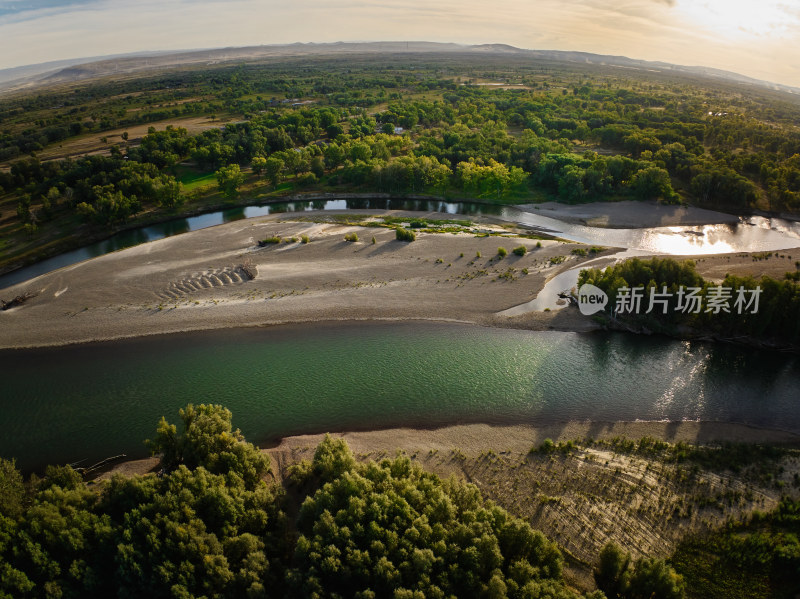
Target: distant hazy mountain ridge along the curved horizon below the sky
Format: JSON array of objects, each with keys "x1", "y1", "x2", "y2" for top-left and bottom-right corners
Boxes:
[{"x1": 0, "y1": 41, "x2": 800, "y2": 95}]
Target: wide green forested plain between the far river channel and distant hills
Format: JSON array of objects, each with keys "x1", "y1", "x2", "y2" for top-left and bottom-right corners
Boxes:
[{"x1": 0, "y1": 55, "x2": 800, "y2": 265}]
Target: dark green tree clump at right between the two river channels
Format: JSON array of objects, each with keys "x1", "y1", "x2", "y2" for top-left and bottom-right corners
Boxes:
[{"x1": 578, "y1": 258, "x2": 800, "y2": 347}]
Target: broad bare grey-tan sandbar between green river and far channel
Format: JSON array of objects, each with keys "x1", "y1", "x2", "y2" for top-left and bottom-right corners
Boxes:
[{"x1": 0, "y1": 213, "x2": 800, "y2": 349}]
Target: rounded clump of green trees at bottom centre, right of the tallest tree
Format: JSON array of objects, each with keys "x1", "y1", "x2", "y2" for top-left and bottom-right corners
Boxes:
[{"x1": 287, "y1": 437, "x2": 576, "y2": 599}]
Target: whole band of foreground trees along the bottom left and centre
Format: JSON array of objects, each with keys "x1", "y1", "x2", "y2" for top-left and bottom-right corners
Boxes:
[{"x1": 0, "y1": 405, "x2": 632, "y2": 599}]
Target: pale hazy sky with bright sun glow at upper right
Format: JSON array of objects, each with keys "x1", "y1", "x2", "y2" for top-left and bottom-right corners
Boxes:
[{"x1": 0, "y1": 0, "x2": 800, "y2": 87}]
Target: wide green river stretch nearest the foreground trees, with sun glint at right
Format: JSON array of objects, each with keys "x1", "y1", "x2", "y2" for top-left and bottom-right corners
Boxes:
[{"x1": 0, "y1": 322, "x2": 800, "y2": 469}]
